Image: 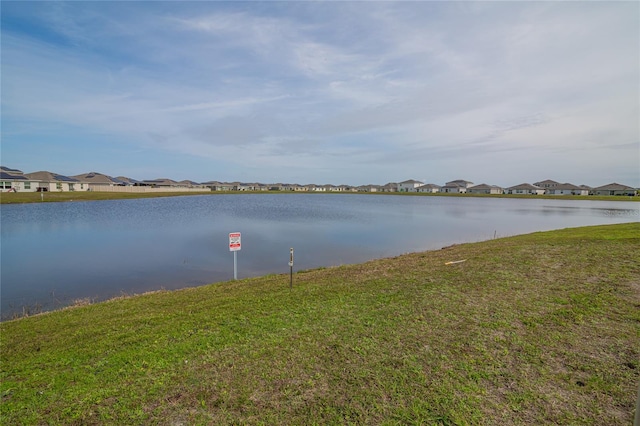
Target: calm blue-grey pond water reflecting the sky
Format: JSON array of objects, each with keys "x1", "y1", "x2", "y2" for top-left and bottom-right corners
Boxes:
[{"x1": 0, "y1": 194, "x2": 640, "y2": 318}]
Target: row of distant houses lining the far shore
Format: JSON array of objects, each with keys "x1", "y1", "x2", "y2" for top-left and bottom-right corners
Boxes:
[{"x1": 0, "y1": 166, "x2": 638, "y2": 195}]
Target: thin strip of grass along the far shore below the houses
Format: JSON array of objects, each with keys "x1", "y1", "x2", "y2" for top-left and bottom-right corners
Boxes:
[{"x1": 0, "y1": 191, "x2": 640, "y2": 204}]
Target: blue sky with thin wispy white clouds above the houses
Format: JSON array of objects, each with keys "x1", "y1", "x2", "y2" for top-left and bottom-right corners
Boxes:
[{"x1": 0, "y1": 1, "x2": 640, "y2": 187}]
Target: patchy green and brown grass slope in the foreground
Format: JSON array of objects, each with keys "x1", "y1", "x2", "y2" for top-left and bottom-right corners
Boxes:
[{"x1": 0, "y1": 223, "x2": 640, "y2": 425}]
